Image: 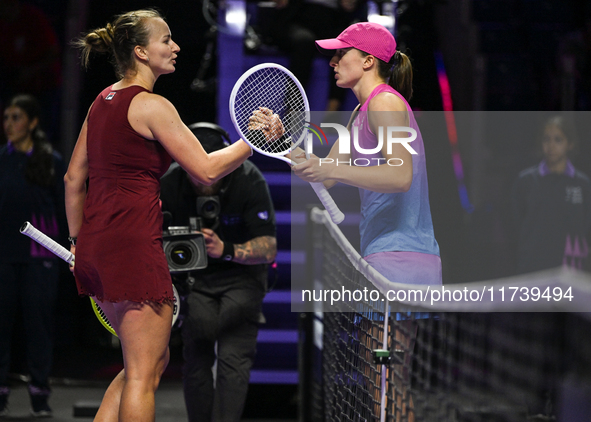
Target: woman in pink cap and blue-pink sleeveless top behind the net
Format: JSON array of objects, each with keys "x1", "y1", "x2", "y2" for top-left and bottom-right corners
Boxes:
[{"x1": 292, "y1": 22, "x2": 442, "y2": 284}]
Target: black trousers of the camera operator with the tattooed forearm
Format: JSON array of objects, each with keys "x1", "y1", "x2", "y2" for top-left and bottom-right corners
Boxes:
[{"x1": 181, "y1": 274, "x2": 266, "y2": 422}]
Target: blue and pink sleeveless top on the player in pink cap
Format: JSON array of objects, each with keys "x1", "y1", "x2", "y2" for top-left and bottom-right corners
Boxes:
[{"x1": 351, "y1": 84, "x2": 439, "y2": 256}]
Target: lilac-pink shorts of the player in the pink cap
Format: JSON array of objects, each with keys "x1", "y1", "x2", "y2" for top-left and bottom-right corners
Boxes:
[{"x1": 363, "y1": 252, "x2": 442, "y2": 285}]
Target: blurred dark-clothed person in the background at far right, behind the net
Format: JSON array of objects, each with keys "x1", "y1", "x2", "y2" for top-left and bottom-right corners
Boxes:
[{"x1": 511, "y1": 116, "x2": 591, "y2": 273}]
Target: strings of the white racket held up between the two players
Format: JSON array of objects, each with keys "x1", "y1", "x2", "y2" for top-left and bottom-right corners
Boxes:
[{"x1": 234, "y1": 68, "x2": 306, "y2": 155}]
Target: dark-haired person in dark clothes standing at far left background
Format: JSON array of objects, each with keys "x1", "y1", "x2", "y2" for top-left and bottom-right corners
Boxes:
[{"x1": 0, "y1": 95, "x2": 65, "y2": 417}]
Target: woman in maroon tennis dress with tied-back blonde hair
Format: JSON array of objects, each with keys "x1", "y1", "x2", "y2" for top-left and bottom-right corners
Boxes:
[{"x1": 64, "y1": 9, "x2": 251, "y2": 422}]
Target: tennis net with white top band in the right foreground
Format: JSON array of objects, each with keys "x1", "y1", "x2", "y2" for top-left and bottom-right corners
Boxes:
[{"x1": 300, "y1": 209, "x2": 591, "y2": 422}]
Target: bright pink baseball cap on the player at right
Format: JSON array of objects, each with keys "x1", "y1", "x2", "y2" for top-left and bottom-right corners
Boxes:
[{"x1": 316, "y1": 22, "x2": 396, "y2": 62}]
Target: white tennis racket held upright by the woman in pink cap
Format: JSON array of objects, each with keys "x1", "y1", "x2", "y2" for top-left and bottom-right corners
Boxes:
[{"x1": 230, "y1": 63, "x2": 345, "y2": 224}]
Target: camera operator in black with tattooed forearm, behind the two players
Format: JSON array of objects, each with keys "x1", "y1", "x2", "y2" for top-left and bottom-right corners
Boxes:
[{"x1": 161, "y1": 123, "x2": 277, "y2": 422}]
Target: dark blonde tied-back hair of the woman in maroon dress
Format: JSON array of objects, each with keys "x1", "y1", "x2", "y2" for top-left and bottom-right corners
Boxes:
[{"x1": 73, "y1": 9, "x2": 164, "y2": 78}]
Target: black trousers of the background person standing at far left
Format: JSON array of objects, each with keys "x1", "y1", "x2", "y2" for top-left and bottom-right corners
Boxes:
[{"x1": 0, "y1": 259, "x2": 59, "y2": 389}]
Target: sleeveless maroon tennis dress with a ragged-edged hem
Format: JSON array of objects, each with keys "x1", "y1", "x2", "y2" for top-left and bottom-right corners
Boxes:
[{"x1": 74, "y1": 86, "x2": 173, "y2": 302}]
